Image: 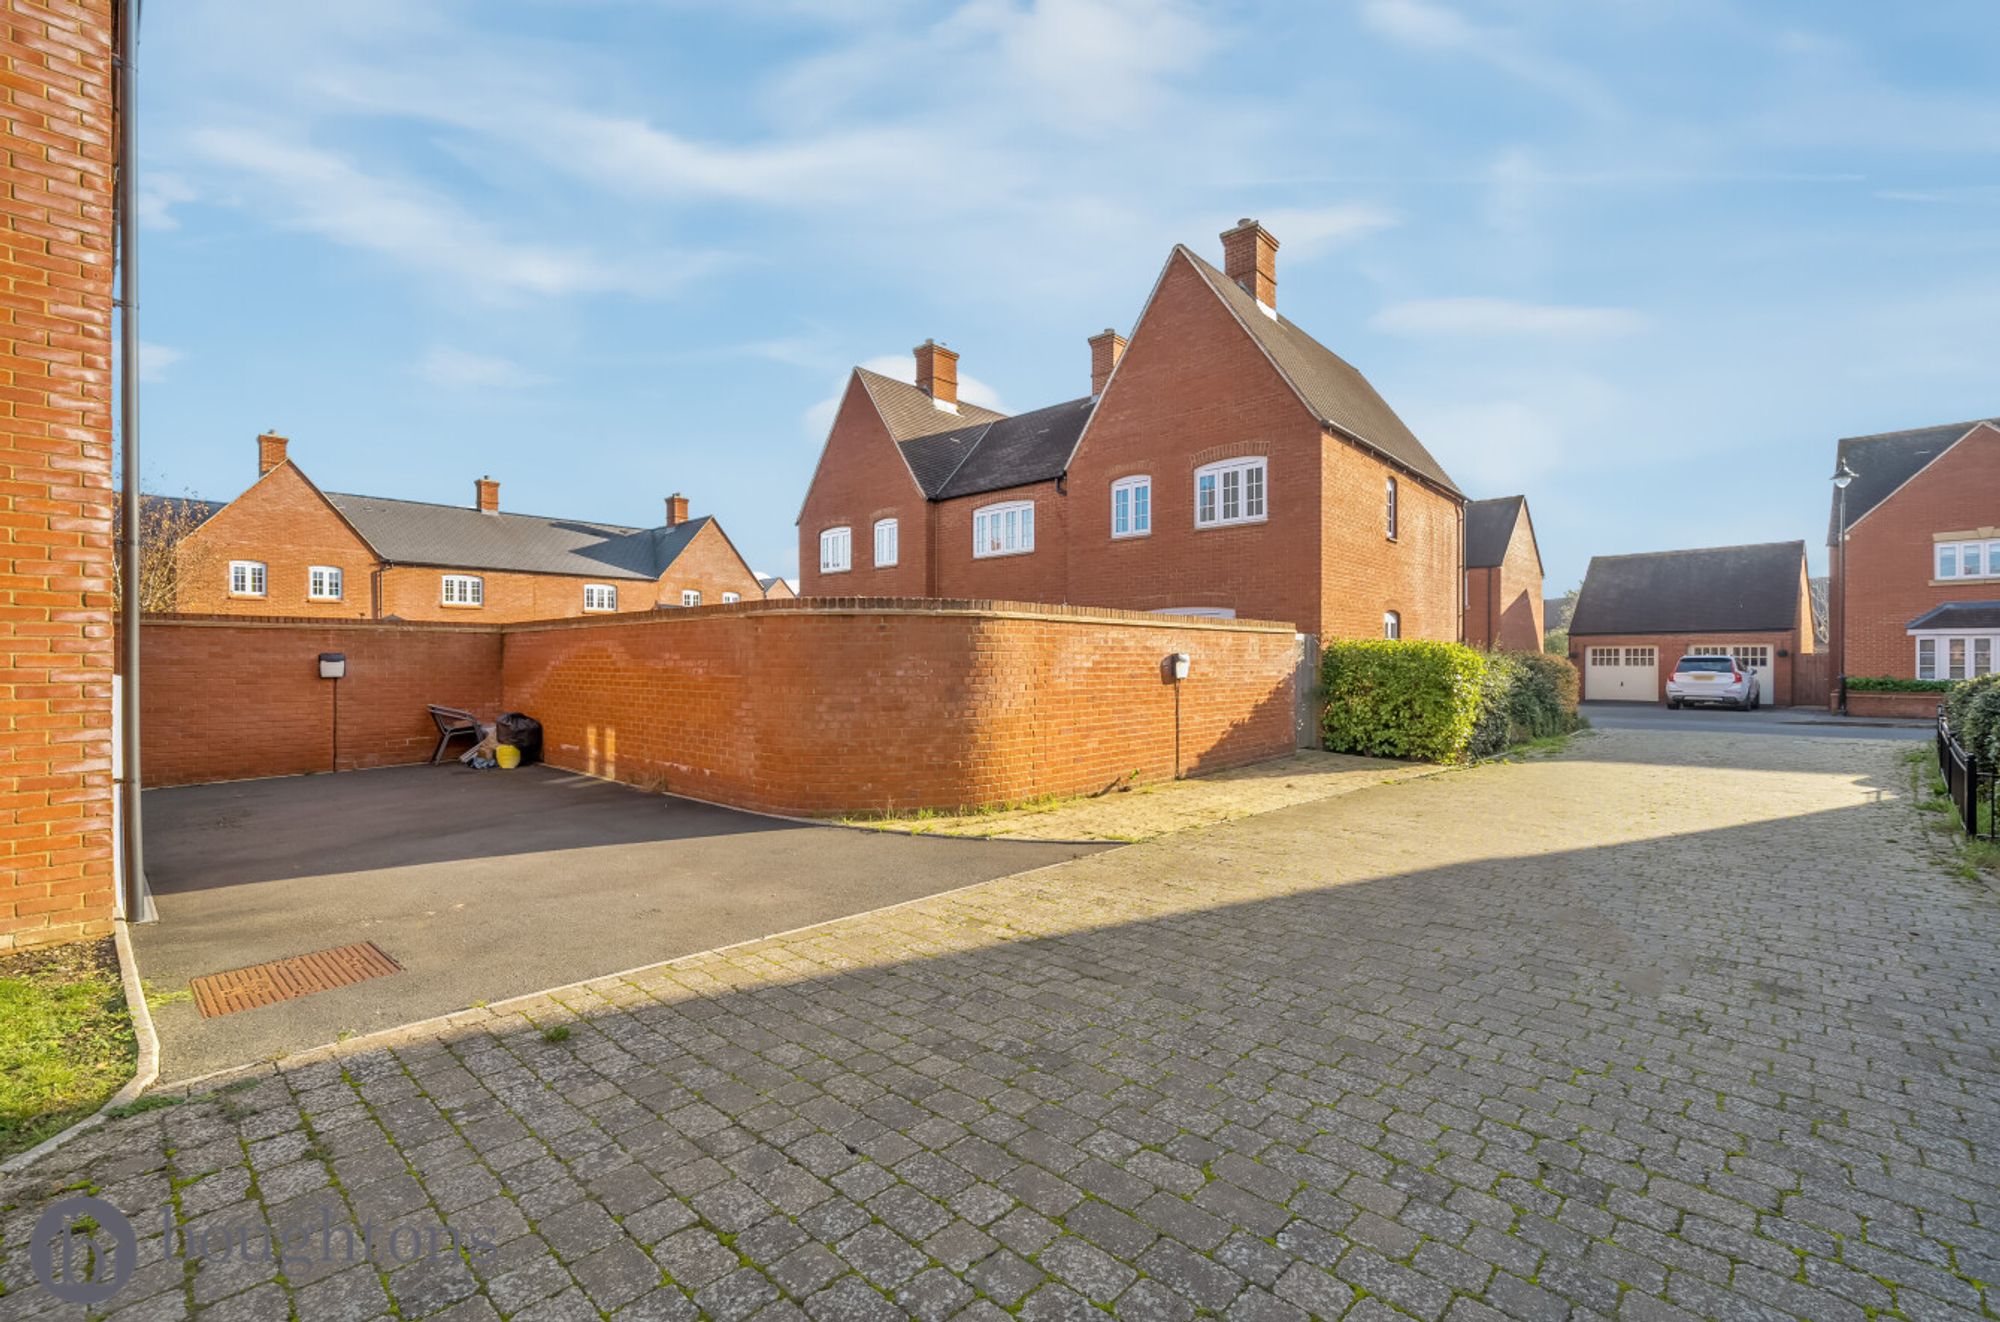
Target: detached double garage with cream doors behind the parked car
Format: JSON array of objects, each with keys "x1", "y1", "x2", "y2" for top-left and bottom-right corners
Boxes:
[{"x1": 1570, "y1": 542, "x2": 1814, "y2": 706}]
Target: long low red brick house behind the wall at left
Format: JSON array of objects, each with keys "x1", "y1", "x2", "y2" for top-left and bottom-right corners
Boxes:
[{"x1": 176, "y1": 432, "x2": 764, "y2": 622}]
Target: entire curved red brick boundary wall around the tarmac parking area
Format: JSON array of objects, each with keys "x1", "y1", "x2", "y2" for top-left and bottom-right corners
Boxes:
[{"x1": 144, "y1": 598, "x2": 1294, "y2": 814}]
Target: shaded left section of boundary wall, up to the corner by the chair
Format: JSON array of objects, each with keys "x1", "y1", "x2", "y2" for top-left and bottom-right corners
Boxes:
[{"x1": 140, "y1": 616, "x2": 504, "y2": 786}]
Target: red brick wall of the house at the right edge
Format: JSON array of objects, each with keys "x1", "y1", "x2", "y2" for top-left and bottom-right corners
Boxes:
[{"x1": 1828, "y1": 426, "x2": 2000, "y2": 676}]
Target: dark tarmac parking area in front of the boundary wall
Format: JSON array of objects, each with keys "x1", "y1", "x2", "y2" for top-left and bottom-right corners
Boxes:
[{"x1": 134, "y1": 766, "x2": 1102, "y2": 1080}]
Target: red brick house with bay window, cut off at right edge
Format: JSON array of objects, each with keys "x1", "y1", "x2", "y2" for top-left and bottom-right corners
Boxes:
[{"x1": 1826, "y1": 420, "x2": 2000, "y2": 680}]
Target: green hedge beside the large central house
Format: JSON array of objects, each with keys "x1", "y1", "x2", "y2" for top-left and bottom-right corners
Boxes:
[{"x1": 1320, "y1": 640, "x2": 1580, "y2": 762}]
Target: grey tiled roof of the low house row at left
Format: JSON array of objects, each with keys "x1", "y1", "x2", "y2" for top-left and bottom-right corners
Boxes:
[{"x1": 326, "y1": 492, "x2": 710, "y2": 578}]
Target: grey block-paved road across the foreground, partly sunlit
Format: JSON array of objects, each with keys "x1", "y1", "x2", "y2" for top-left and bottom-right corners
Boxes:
[{"x1": 0, "y1": 732, "x2": 2000, "y2": 1322}]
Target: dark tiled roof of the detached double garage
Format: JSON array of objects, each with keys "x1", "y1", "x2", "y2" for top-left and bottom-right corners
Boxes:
[{"x1": 1570, "y1": 542, "x2": 1806, "y2": 638}]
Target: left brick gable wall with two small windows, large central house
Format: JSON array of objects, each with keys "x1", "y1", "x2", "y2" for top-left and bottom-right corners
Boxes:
[{"x1": 798, "y1": 376, "x2": 936, "y2": 596}]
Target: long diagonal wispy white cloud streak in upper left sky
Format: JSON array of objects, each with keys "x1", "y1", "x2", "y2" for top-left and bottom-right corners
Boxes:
[{"x1": 190, "y1": 128, "x2": 680, "y2": 296}]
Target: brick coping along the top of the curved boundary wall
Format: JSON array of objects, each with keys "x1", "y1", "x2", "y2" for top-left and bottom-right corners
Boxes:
[{"x1": 142, "y1": 596, "x2": 1296, "y2": 634}]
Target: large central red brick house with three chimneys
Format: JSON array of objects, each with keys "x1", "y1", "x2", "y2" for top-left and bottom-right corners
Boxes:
[{"x1": 798, "y1": 220, "x2": 1466, "y2": 640}]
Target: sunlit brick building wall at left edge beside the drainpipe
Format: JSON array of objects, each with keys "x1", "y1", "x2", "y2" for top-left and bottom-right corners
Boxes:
[{"x1": 0, "y1": 0, "x2": 114, "y2": 950}]
